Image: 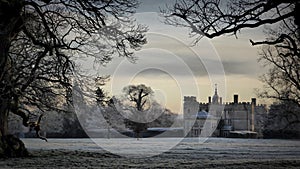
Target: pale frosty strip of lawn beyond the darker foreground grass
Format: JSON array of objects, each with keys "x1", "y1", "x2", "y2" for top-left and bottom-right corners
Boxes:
[{"x1": 23, "y1": 138, "x2": 300, "y2": 158}]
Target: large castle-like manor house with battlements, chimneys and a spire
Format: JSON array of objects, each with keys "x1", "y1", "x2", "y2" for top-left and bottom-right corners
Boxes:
[{"x1": 183, "y1": 87, "x2": 267, "y2": 137}]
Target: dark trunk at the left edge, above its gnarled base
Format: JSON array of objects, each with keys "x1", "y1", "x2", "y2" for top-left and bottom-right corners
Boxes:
[{"x1": 0, "y1": 0, "x2": 23, "y2": 136}]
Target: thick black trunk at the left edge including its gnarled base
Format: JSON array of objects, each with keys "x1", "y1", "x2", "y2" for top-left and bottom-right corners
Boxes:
[{"x1": 0, "y1": 0, "x2": 28, "y2": 157}]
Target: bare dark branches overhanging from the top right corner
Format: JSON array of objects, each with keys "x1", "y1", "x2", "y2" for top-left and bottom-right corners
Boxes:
[{"x1": 162, "y1": 0, "x2": 299, "y2": 40}]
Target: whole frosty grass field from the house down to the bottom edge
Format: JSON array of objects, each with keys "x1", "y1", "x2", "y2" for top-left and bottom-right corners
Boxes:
[{"x1": 0, "y1": 138, "x2": 300, "y2": 169}]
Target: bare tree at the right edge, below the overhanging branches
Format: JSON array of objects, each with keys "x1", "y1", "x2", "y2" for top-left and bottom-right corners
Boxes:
[{"x1": 258, "y1": 19, "x2": 300, "y2": 105}]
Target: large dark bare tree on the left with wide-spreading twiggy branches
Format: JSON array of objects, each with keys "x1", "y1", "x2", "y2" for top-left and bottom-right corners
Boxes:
[{"x1": 0, "y1": 0, "x2": 146, "y2": 156}]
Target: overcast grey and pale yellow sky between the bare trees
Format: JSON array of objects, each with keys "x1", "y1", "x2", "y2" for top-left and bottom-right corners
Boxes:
[{"x1": 94, "y1": 0, "x2": 264, "y2": 113}]
